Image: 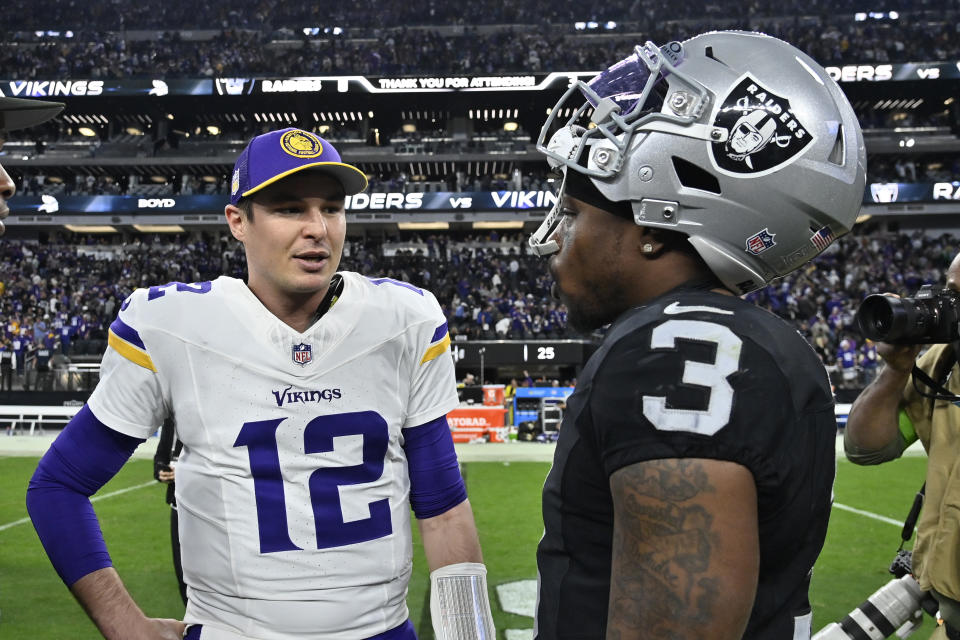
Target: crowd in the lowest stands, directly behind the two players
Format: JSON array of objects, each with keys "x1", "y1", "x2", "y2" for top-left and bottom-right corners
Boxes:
[{"x1": 0, "y1": 231, "x2": 958, "y2": 387}]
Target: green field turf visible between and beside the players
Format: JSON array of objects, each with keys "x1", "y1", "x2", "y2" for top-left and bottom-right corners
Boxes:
[{"x1": 0, "y1": 452, "x2": 932, "y2": 640}]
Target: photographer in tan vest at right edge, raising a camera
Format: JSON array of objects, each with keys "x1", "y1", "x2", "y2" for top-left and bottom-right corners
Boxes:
[{"x1": 844, "y1": 255, "x2": 960, "y2": 640}]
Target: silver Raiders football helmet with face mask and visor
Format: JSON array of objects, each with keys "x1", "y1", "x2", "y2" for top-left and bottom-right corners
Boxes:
[{"x1": 529, "y1": 31, "x2": 866, "y2": 294}]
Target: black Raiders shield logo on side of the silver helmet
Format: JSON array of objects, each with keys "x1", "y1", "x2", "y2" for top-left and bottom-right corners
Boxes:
[{"x1": 710, "y1": 75, "x2": 813, "y2": 175}]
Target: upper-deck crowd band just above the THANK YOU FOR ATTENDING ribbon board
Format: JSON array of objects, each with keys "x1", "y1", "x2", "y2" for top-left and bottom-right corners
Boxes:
[{"x1": 0, "y1": 3, "x2": 960, "y2": 80}]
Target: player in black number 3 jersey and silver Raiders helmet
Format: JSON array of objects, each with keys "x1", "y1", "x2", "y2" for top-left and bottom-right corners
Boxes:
[{"x1": 530, "y1": 32, "x2": 865, "y2": 640}]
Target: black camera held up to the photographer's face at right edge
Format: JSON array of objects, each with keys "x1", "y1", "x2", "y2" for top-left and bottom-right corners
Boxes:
[{"x1": 857, "y1": 284, "x2": 960, "y2": 344}]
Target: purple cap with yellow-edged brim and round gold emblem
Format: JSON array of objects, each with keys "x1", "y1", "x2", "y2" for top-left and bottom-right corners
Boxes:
[{"x1": 230, "y1": 127, "x2": 367, "y2": 205}]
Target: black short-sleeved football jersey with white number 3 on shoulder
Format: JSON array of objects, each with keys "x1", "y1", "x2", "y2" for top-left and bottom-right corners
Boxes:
[{"x1": 534, "y1": 288, "x2": 837, "y2": 640}]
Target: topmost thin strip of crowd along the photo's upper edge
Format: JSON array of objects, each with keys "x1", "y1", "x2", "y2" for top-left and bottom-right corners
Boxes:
[{"x1": 4, "y1": 0, "x2": 954, "y2": 32}]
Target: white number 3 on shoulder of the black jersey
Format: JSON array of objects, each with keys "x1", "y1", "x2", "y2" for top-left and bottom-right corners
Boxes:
[{"x1": 643, "y1": 320, "x2": 743, "y2": 436}]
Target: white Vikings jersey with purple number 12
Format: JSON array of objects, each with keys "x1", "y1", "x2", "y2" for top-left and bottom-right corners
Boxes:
[{"x1": 89, "y1": 272, "x2": 457, "y2": 640}]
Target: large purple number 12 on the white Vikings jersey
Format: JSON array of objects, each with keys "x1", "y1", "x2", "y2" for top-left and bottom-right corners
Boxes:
[{"x1": 233, "y1": 411, "x2": 393, "y2": 553}]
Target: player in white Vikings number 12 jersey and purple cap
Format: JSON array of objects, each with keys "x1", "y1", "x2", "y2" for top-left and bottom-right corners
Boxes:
[{"x1": 27, "y1": 129, "x2": 495, "y2": 640}]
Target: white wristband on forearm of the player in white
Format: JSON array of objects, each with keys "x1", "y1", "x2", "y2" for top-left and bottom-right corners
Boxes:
[{"x1": 430, "y1": 562, "x2": 497, "y2": 640}]
